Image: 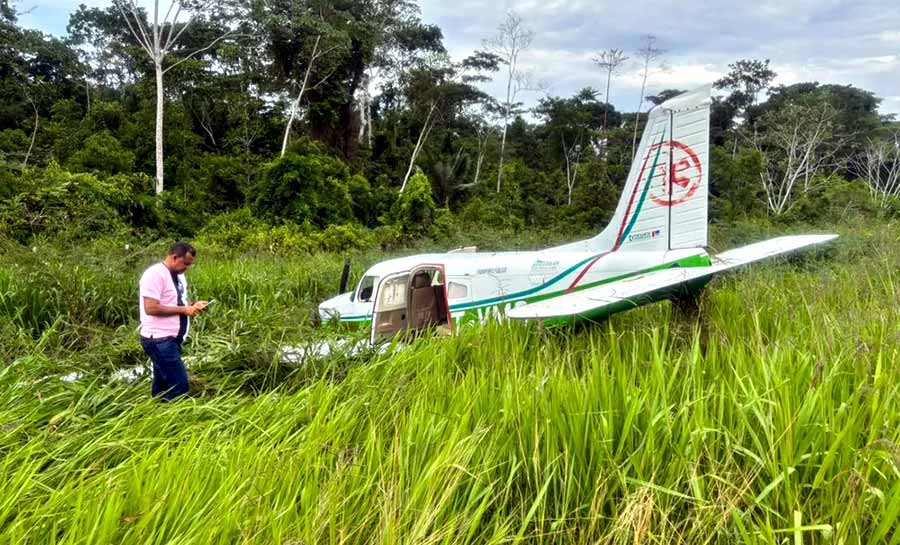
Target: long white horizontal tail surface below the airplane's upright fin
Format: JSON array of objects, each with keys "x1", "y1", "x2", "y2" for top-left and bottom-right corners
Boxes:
[{"x1": 506, "y1": 235, "x2": 837, "y2": 320}]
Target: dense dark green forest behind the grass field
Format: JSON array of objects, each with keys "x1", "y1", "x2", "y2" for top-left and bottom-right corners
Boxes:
[{"x1": 0, "y1": 0, "x2": 900, "y2": 251}]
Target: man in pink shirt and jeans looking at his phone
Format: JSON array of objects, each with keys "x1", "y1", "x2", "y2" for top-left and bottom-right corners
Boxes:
[{"x1": 139, "y1": 242, "x2": 208, "y2": 401}]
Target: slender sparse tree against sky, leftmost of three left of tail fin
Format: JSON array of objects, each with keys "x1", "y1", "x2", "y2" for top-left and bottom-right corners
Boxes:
[{"x1": 484, "y1": 11, "x2": 534, "y2": 193}]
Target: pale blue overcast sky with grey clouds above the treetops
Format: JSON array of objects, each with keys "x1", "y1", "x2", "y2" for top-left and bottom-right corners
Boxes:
[{"x1": 17, "y1": 0, "x2": 900, "y2": 113}]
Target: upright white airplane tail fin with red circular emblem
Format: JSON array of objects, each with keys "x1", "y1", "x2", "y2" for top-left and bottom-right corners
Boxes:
[{"x1": 553, "y1": 85, "x2": 712, "y2": 252}]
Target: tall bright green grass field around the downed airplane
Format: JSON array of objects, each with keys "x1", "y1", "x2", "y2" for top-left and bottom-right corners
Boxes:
[{"x1": 0, "y1": 224, "x2": 900, "y2": 545}]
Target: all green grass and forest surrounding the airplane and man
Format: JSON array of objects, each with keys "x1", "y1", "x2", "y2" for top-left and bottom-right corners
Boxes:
[{"x1": 0, "y1": 0, "x2": 900, "y2": 545}]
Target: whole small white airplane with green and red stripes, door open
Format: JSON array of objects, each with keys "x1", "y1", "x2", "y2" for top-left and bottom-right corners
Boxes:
[{"x1": 319, "y1": 86, "x2": 837, "y2": 343}]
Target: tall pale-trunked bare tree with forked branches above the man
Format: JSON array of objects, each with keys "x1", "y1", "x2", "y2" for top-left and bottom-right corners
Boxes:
[{"x1": 113, "y1": 0, "x2": 230, "y2": 195}]
